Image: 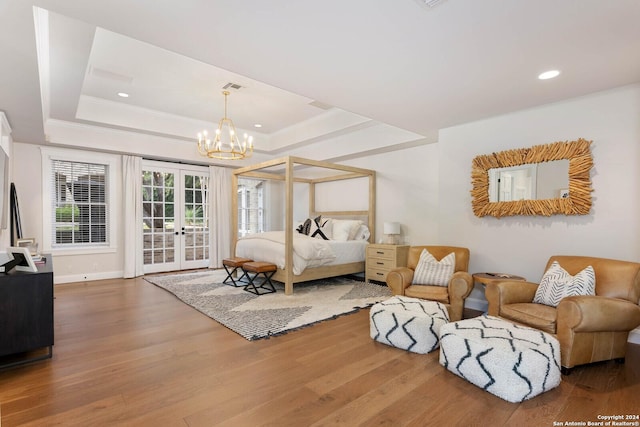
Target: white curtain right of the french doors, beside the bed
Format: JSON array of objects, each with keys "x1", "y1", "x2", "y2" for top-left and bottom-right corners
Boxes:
[{"x1": 209, "y1": 166, "x2": 234, "y2": 268}]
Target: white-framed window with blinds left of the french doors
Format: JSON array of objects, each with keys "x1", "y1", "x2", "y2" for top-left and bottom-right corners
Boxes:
[{"x1": 43, "y1": 149, "x2": 117, "y2": 253}]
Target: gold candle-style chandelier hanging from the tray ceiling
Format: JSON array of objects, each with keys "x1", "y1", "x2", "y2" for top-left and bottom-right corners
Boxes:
[{"x1": 198, "y1": 90, "x2": 253, "y2": 160}]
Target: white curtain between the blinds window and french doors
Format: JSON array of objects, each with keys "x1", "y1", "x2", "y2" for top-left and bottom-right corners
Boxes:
[{"x1": 122, "y1": 156, "x2": 144, "y2": 279}]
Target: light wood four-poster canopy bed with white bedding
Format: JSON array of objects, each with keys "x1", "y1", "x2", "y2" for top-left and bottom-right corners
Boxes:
[{"x1": 232, "y1": 156, "x2": 376, "y2": 295}]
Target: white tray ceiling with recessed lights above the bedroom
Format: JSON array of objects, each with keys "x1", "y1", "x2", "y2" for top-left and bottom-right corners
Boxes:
[{"x1": 0, "y1": 0, "x2": 640, "y2": 163}]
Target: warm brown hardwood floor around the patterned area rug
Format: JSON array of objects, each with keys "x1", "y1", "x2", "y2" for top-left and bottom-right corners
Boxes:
[{"x1": 0, "y1": 278, "x2": 640, "y2": 427}]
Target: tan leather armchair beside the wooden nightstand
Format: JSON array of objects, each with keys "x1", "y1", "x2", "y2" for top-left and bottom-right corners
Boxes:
[{"x1": 387, "y1": 246, "x2": 473, "y2": 322}]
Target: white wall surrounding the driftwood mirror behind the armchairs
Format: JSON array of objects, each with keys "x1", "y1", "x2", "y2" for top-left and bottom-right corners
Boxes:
[{"x1": 438, "y1": 85, "x2": 640, "y2": 308}]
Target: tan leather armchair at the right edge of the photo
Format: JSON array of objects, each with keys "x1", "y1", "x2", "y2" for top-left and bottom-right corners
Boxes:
[{"x1": 485, "y1": 256, "x2": 640, "y2": 373}]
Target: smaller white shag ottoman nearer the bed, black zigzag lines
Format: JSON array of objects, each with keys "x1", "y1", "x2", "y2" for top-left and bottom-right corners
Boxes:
[{"x1": 369, "y1": 295, "x2": 449, "y2": 354}]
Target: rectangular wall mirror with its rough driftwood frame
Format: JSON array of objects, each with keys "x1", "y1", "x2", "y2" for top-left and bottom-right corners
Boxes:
[{"x1": 471, "y1": 138, "x2": 593, "y2": 218}]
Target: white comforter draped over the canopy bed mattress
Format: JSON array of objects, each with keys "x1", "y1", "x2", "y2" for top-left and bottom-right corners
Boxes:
[{"x1": 236, "y1": 231, "x2": 367, "y2": 275}]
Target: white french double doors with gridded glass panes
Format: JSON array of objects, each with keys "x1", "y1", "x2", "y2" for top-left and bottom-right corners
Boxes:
[{"x1": 141, "y1": 161, "x2": 209, "y2": 273}]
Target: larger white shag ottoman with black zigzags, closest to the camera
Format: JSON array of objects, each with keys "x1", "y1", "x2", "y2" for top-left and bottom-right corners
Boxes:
[{"x1": 440, "y1": 315, "x2": 560, "y2": 402}]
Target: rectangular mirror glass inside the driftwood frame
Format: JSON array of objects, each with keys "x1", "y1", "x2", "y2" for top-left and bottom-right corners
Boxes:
[{"x1": 488, "y1": 159, "x2": 569, "y2": 202}]
